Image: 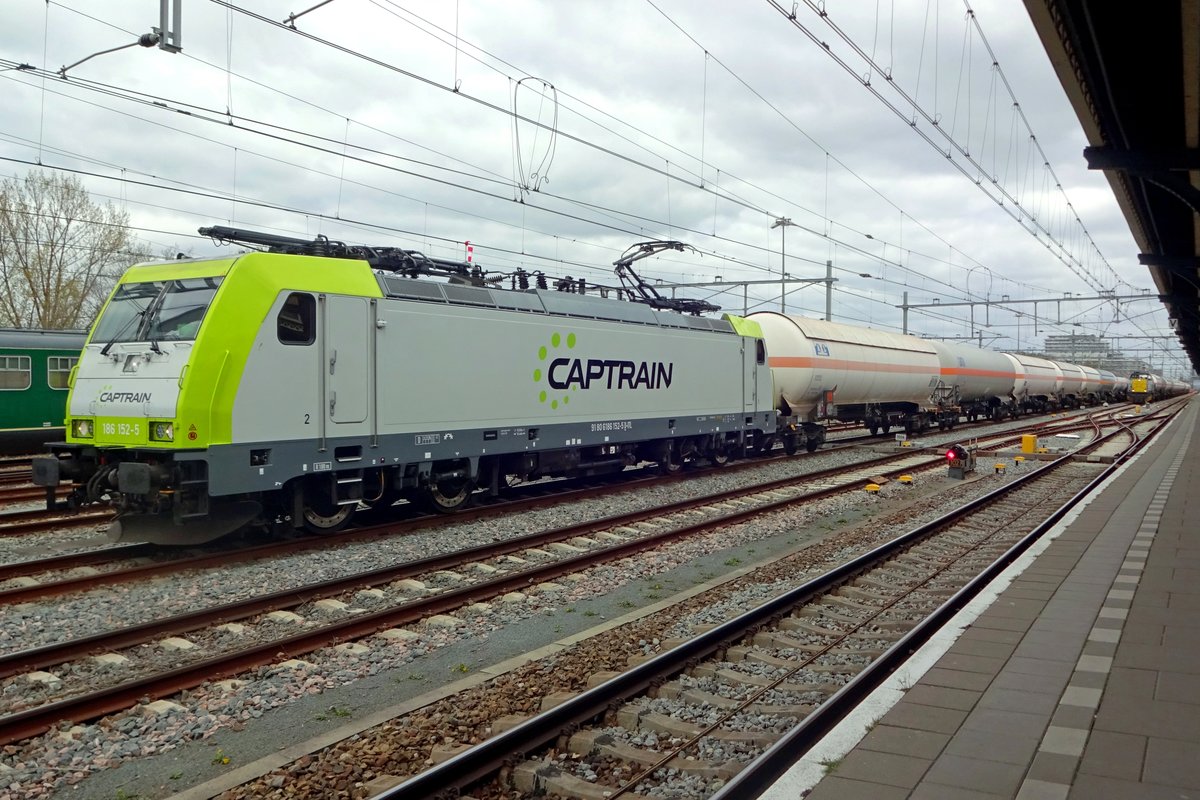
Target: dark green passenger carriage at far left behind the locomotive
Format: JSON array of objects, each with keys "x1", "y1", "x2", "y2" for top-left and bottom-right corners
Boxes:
[{"x1": 0, "y1": 327, "x2": 88, "y2": 455}]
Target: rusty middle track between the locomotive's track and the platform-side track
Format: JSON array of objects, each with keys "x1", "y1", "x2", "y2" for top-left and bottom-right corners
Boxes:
[{"x1": 0, "y1": 407, "x2": 1161, "y2": 744}]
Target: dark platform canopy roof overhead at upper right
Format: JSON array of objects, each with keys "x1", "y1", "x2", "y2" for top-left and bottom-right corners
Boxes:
[{"x1": 1025, "y1": 0, "x2": 1200, "y2": 372}]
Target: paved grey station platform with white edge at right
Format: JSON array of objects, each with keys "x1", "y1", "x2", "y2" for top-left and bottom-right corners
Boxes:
[{"x1": 762, "y1": 401, "x2": 1200, "y2": 800}]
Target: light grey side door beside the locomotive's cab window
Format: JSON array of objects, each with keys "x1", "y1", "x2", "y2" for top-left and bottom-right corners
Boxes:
[{"x1": 320, "y1": 295, "x2": 371, "y2": 425}]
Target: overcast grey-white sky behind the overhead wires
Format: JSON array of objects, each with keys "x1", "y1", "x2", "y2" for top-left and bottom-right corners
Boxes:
[{"x1": 0, "y1": 0, "x2": 1186, "y2": 372}]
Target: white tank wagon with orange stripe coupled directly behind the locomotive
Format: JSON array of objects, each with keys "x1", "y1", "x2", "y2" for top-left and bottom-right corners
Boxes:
[{"x1": 748, "y1": 312, "x2": 958, "y2": 443}]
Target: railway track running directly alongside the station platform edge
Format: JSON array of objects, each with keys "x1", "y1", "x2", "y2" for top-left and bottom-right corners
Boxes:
[{"x1": 364, "y1": 407, "x2": 1171, "y2": 800}]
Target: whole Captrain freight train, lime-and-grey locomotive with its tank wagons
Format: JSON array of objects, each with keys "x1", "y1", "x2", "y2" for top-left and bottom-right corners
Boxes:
[{"x1": 34, "y1": 228, "x2": 1171, "y2": 543}]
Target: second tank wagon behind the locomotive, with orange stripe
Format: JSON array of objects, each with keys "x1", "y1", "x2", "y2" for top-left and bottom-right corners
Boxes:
[{"x1": 929, "y1": 341, "x2": 1024, "y2": 422}]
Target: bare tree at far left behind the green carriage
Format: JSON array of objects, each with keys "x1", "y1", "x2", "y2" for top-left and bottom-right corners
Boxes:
[{"x1": 0, "y1": 172, "x2": 149, "y2": 329}]
